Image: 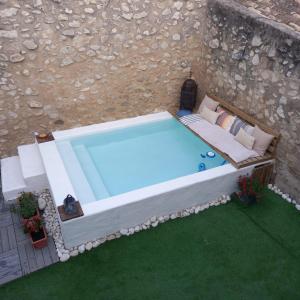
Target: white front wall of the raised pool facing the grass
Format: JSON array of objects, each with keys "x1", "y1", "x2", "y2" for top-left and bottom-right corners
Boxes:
[{"x1": 61, "y1": 165, "x2": 253, "y2": 248}]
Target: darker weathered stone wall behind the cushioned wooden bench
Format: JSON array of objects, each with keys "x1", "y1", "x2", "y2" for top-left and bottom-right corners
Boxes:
[{"x1": 194, "y1": 0, "x2": 300, "y2": 199}]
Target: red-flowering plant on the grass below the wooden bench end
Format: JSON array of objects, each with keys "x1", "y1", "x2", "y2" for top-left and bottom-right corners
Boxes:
[{"x1": 234, "y1": 175, "x2": 263, "y2": 205}]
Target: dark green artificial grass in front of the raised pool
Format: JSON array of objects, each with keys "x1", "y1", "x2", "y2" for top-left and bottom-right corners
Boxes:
[{"x1": 0, "y1": 191, "x2": 300, "y2": 300}]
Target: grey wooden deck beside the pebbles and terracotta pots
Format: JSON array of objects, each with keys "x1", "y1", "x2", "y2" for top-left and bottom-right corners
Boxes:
[{"x1": 0, "y1": 171, "x2": 58, "y2": 285}]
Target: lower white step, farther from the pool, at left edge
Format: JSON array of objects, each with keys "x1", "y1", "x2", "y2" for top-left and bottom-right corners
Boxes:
[{"x1": 1, "y1": 156, "x2": 28, "y2": 201}]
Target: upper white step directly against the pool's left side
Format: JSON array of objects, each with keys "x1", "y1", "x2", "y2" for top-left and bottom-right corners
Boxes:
[{"x1": 18, "y1": 144, "x2": 49, "y2": 191}]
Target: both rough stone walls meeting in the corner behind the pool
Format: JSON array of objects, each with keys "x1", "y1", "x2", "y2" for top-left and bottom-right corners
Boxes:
[{"x1": 0, "y1": 0, "x2": 300, "y2": 202}]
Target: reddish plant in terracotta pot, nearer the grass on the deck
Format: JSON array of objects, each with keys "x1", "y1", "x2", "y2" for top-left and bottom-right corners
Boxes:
[{"x1": 22, "y1": 215, "x2": 48, "y2": 249}]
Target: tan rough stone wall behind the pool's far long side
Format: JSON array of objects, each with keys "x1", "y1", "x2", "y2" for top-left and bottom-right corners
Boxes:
[{"x1": 0, "y1": 0, "x2": 206, "y2": 157}]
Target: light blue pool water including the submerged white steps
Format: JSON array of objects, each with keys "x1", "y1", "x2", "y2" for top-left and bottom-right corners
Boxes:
[{"x1": 57, "y1": 118, "x2": 227, "y2": 202}]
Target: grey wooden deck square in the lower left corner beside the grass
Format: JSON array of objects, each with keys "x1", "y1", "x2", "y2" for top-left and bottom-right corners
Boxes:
[{"x1": 0, "y1": 249, "x2": 22, "y2": 284}]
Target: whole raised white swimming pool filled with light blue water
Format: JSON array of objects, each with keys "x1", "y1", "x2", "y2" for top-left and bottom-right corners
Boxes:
[{"x1": 38, "y1": 112, "x2": 262, "y2": 248}]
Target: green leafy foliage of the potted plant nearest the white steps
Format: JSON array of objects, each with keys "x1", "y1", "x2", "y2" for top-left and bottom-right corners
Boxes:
[{"x1": 12, "y1": 192, "x2": 37, "y2": 219}]
